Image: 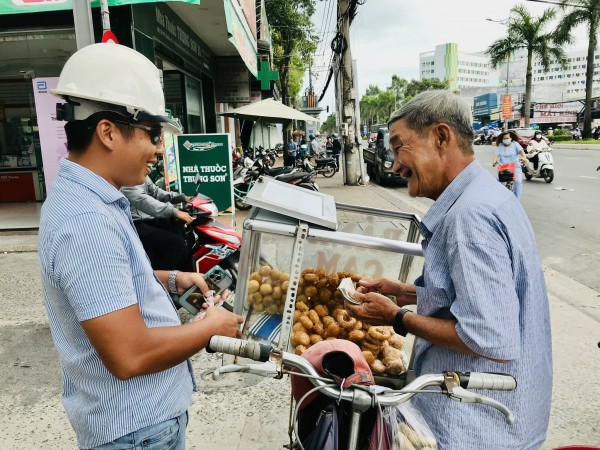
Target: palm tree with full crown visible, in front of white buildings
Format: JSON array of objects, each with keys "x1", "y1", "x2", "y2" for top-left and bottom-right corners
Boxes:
[{"x1": 486, "y1": 4, "x2": 571, "y2": 127}]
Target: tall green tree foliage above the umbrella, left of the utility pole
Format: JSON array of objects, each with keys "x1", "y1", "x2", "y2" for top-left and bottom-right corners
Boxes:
[{"x1": 265, "y1": 0, "x2": 318, "y2": 106}]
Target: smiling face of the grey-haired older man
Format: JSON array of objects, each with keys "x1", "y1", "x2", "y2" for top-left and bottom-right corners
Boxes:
[{"x1": 390, "y1": 119, "x2": 445, "y2": 200}]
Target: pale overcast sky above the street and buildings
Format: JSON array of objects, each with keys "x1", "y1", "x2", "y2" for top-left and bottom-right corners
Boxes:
[{"x1": 313, "y1": 0, "x2": 587, "y2": 120}]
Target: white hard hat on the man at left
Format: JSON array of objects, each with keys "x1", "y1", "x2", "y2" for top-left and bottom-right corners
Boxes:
[{"x1": 50, "y1": 43, "x2": 183, "y2": 134}]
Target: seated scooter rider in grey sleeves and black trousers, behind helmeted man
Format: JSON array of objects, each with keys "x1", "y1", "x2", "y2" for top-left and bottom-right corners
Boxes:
[{"x1": 121, "y1": 177, "x2": 194, "y2": 272}]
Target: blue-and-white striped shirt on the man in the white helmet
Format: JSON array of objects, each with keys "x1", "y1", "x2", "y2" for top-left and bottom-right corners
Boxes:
[{"x1": 39, "y1": 159, "x2": 195, "y2": 448}]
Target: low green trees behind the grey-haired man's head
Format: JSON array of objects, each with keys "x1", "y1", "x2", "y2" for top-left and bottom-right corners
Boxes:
[{"x1": 360, "y1": 75, "x2": 448, "y2": 125}]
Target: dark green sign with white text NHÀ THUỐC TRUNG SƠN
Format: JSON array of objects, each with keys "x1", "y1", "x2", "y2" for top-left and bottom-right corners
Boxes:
[{"x1": 177, "y1": 134, "x2": 233, "y2": 213}]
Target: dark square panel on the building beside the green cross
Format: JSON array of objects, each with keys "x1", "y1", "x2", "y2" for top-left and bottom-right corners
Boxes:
[{"x1": 215, "y1": 57, "x2": 250, "y2": 103}]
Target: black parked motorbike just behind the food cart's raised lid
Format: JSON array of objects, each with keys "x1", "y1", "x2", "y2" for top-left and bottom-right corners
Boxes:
[{"x1": 233, "y1": 157, "x2": 319, "y2": 211}]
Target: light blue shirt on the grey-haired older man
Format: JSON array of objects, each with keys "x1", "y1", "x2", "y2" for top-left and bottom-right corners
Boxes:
[{"x1": 414, "y1": 161, "x2": 552, "y2": 450}]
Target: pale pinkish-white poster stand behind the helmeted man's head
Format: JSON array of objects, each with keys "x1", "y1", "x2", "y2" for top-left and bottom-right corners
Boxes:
[{"x1": 33, "y1": 77, "x2": 67, "y2": 192}]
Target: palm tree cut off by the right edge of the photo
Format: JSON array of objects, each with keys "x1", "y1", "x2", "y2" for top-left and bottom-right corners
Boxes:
[{"x1": 557, "y1": 0, "x2": 600, "y2": 139}]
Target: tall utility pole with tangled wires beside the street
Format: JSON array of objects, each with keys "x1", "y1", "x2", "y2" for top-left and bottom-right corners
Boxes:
[{"x1": 338, "y1": 0, "x2": 362, "y2": 186}]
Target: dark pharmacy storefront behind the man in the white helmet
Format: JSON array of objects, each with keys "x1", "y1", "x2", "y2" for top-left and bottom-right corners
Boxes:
[{"x1": 0, "y1": 0, "x2": 256, "y2": 202}]
